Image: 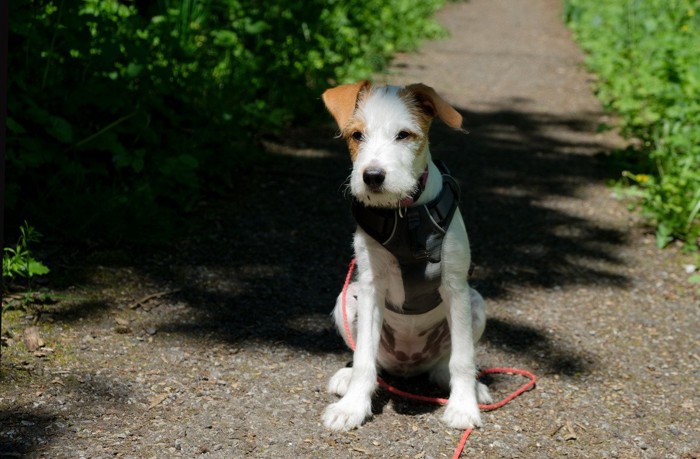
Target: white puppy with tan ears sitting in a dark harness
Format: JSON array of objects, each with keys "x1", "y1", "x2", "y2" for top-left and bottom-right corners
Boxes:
[{"x1": 322, "y1": 81, "x2": 491, "y2": 431}]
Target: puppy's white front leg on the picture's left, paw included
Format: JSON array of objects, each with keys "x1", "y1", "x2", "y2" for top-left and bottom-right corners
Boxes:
[{"x1": 323, "y1": 272, "x2": 385, "y2": 430}]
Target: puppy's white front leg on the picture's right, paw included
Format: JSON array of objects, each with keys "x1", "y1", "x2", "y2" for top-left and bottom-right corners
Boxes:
[{"x1": 440, "y1": 281, "x2": 481, "y2": 429}]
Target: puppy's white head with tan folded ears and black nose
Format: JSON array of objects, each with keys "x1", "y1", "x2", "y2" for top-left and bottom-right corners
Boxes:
[{"x1": 323, "y1": 81, "x2": 462, "y2": 207}]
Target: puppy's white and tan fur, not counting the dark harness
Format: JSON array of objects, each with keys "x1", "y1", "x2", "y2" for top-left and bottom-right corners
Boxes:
[{"x1": 323, "y1": 81, "x2": 490, "y2": 430}]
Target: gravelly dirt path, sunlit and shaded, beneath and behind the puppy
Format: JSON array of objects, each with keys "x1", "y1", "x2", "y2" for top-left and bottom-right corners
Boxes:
[{"x1": 0, "y1": 0, "x2": 700, "y2": 459}]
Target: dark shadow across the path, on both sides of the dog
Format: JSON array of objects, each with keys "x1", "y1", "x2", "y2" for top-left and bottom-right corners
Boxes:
[{"x1": 52, "y1": 100, "x2": 628, "y2": 373}]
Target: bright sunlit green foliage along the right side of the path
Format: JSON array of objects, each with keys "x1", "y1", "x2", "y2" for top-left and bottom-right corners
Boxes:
[{"x1": 566, "y1": 0, "x2": 700, "y2": 249}]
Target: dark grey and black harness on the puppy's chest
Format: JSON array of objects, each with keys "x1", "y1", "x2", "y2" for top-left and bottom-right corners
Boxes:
[{"x1": 352, "y1": 161, "x2": 460, "y2": 315}]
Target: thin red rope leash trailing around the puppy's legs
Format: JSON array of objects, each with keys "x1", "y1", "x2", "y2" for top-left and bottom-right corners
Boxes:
[{"x1": 340, "y1": 258, "x2": 537, "y2": 459}]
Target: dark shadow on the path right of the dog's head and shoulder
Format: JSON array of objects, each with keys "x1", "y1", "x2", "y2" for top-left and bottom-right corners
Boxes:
[{"x1": 433, "y1": 104, "x2": 628, "y2": 297}]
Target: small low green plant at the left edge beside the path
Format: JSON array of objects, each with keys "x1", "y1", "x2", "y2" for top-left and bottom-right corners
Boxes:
[{"x1": 2, "y1": 222, "x2": 49, "y2": 290}]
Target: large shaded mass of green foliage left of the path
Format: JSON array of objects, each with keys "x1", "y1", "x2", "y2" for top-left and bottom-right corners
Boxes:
[{"x1": 6, "y1": 0, "x2": 443, "y2": 243}]
